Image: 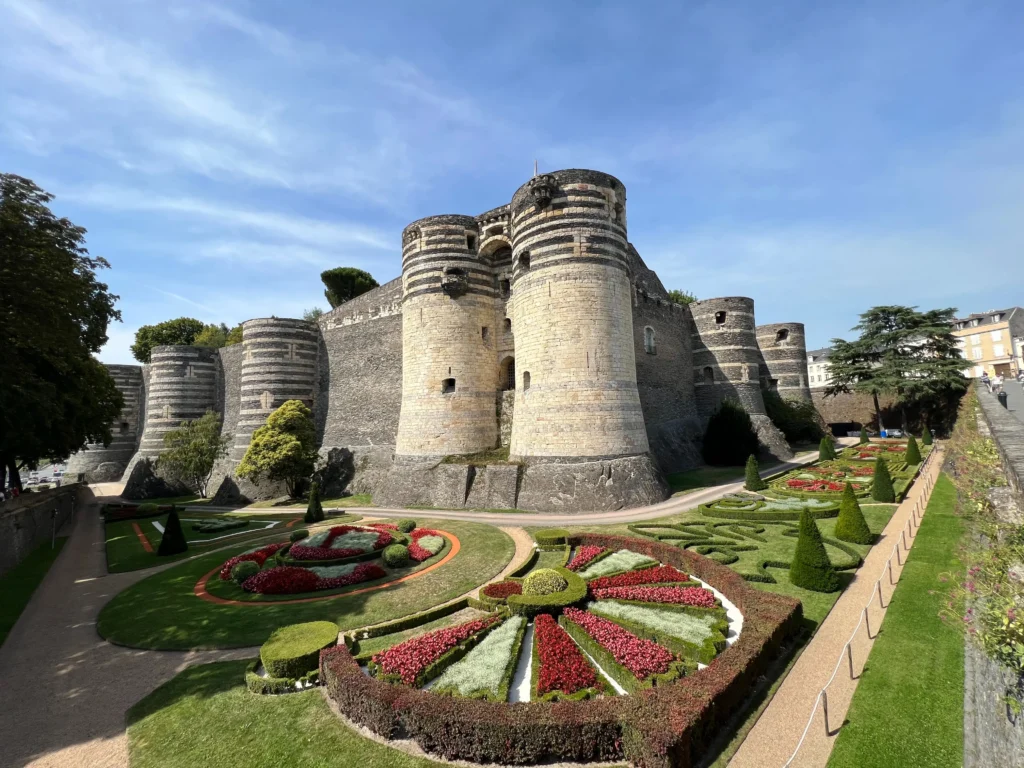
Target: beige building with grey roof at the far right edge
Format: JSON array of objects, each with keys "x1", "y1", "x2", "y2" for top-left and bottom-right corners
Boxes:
[{"x1": 953, "y1": 306, "x2": 1024, "y2": 379}]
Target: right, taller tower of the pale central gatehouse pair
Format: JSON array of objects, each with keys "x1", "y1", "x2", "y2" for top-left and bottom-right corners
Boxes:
[{"x1": 510, "y1": 170, "x2": 648, "y2": 459}]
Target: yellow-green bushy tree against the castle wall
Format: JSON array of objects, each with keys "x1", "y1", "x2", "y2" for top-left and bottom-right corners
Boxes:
[{"x1": 236, "y1": 400, "x2": 316, "y2": 499}]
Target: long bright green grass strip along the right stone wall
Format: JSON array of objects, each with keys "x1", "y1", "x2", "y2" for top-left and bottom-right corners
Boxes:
[{"x1": 828, "y1": 475, "x2": 964, "y2": 768}]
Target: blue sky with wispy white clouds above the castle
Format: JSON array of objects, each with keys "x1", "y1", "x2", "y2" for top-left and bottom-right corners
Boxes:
[{"x1": 0, "y1": 0, "x2": 1024, "y2": 362}]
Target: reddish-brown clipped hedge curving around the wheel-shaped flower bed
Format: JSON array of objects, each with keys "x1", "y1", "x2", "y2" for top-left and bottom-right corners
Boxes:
[{"x1": 321, "y1": 534, "x2": 803, "y2": 768}]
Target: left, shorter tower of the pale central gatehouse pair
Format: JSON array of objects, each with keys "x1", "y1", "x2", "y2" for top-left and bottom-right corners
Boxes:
[{"x1": 395, "y1": 215, "x2": 500, "y2": 456}]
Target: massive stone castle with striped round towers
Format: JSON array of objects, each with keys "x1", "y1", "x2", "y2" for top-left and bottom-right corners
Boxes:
[{"x1": 68, "y1": 170, "x2": 811, "y2": 511}]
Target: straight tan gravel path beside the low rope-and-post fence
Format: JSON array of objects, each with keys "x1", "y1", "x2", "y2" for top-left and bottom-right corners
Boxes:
[{"x1": 729, "y1": 447, "x2": 942, "y2": 768}]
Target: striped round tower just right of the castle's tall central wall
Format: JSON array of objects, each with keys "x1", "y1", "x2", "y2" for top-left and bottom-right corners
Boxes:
[{"x1": 690, "y1": 296, "x2": 765, "y2": 422}]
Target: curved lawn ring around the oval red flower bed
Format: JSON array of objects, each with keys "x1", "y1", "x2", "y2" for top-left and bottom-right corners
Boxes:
[{"x1": 97, "y1": 520, "x2": 515, "y2": 650}]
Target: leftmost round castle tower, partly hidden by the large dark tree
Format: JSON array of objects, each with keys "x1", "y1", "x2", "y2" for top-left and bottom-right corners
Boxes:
[{"x1": 67, "y1": 366, "x2": 142, "y2": 482}]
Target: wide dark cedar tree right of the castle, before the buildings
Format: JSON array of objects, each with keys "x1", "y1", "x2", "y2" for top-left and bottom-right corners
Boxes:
[{"x1": 825, "y1": 306, "x2": 968, "y2": 432}]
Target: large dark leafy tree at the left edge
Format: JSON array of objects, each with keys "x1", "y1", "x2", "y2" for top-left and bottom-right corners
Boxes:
[{"x1": 0, "y1": 174, "x2": 124, "y2": 488}]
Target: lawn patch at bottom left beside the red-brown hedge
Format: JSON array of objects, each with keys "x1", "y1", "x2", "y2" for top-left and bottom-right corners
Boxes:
[{"x1": 128, "y1": 660, "x2": 439, "y2": 768}]
